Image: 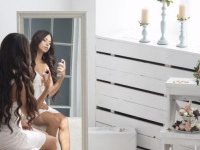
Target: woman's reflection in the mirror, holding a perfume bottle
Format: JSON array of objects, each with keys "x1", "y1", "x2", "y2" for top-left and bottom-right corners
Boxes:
[{"x1": 30, "y1": 30, "x2": 70, "y2": 150}]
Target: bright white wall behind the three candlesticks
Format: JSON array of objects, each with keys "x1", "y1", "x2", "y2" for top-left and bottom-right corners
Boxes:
[{"x1": 96, "y1": 0, "x2": 200, "y2": 46}]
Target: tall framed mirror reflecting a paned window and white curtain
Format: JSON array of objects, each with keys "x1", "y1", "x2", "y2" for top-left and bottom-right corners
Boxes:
[{"x1": 17, "y1": 11, "x2": 88, "y2": 150}]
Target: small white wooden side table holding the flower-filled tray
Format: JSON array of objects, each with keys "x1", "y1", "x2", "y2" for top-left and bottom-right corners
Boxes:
[{"x1": 160, "y1": 78, "x2": 200, "y2": 150}]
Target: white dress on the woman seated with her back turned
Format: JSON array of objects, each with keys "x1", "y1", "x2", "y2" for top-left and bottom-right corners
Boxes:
[{"x1": 0, "y1": 102, "x2": 46, "y2": 150}]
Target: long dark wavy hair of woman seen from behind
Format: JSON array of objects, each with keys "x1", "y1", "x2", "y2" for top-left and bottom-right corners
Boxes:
[{"x1": 0, "y1": 33, "x2": 37, "y2": 132}]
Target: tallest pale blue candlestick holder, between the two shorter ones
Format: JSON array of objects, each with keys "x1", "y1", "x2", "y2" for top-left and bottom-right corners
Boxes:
[{"x1": 157, "y1": 0, "x2": 168, "y2": 45}]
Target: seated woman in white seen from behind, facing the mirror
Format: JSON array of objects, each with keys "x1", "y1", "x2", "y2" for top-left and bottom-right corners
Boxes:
[{"x1": 0, "y1": 33, "x2": 57, "y2": 150}]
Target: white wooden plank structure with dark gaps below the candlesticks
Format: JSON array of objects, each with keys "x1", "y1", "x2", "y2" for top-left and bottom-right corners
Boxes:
[{"x1": 96, "y1": 33, "x2": 200, "y2": 150}]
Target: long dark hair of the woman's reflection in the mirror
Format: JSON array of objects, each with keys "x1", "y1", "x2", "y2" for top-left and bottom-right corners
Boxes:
[{"x1": 30, "y1": 30, "x2": 58, "y2": 99}]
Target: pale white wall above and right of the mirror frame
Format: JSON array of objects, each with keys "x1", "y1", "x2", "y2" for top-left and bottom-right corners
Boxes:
[{"x1": 0, "y1": 0, "x2": 95, "y2": 126}]
